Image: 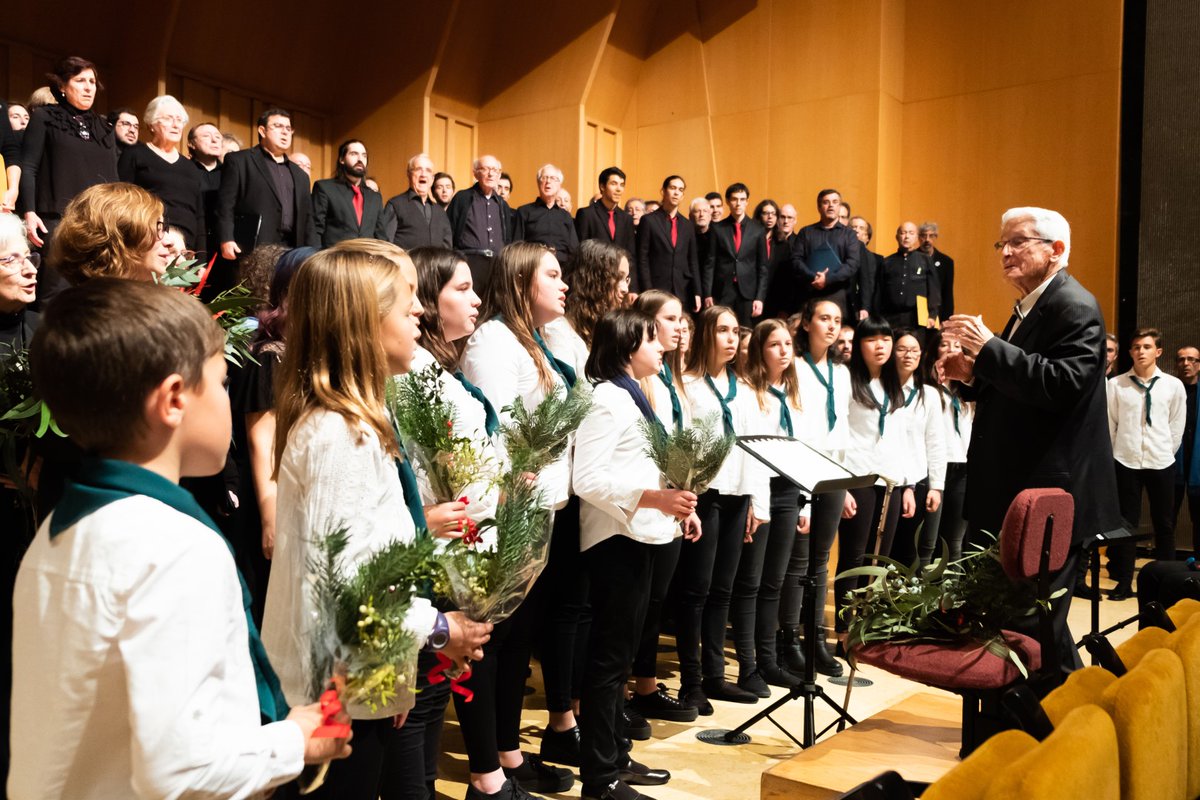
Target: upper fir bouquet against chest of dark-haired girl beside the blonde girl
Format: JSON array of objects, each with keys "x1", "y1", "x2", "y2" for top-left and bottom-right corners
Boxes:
[{"x1": 388, "y1": 363, "x2": 496, "y2": 513}]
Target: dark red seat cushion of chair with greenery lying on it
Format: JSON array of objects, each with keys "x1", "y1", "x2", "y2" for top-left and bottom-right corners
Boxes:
[{"x1": 854, "y1": 631, "x2": 1042, "y2": 690}]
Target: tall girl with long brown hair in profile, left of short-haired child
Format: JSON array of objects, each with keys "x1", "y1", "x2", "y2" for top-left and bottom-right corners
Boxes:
[{"x1": 457, "y1": 242, "x2": 578, "y2": 800}]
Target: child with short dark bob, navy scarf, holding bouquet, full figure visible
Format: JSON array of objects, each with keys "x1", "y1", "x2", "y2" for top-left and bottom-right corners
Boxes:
[{"x1": 574, "y1": 309, "x2": 700, "y2": 798}]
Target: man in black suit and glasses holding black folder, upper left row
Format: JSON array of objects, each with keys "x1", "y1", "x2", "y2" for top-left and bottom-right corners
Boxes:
[{"x1": 217, "y1": 108, "x2": 320, "y2": 261}]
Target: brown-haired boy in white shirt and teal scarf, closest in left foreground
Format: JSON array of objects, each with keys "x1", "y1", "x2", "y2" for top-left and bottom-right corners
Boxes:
[{"x1": 8, "y1": 278, "x2": 349, "y2": 800}]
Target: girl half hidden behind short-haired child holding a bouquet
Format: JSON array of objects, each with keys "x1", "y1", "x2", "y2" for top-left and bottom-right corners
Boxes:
[{"x1": 630, "y1": 289, "x2": 696, "y2": 722}]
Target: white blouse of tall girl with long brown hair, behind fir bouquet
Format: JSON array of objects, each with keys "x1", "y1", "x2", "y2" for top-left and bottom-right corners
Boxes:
[{"x1": 462, "y1": 319, "x2": 571, "y2": 509}]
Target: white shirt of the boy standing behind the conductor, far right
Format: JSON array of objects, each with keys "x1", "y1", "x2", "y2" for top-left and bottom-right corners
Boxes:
[{"x1": 1104, "y1": 367, "x2": 1188, "y2": 469}]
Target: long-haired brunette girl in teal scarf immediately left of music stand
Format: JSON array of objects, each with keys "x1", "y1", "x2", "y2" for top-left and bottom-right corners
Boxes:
[{"x1": 676, "y1": 306, "x2": 768, "y2": 716}]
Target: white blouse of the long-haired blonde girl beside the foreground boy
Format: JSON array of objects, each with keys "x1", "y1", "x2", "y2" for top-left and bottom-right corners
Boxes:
[{"x1": 263, "y1": 409, "x2": 437, "y2": 720}]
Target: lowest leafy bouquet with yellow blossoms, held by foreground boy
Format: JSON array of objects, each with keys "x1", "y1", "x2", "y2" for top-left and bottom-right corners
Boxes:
[{"x1": 308, "y1": 528, "x2": 434, "y2": 712}]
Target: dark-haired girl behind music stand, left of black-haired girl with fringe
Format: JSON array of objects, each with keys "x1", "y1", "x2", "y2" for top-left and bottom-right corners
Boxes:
[{"x1": 779, "y1": 300, "x2": 853, "y2": 678}]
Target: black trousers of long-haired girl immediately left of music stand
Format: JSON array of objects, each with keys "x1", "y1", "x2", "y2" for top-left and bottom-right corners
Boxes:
[{"x1": 676, "y1": 489, "x2": 750, "y2": 687}]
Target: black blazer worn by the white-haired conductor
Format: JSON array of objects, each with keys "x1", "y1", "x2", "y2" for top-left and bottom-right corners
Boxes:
[{"x1": 964, "y1": 272, "x2": 1121, "y2": 543}]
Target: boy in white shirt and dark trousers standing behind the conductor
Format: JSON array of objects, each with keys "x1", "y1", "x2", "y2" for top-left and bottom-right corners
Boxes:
[{"x1": 1106, "y1": 327, "x2": 1187, "y2": 600}]
